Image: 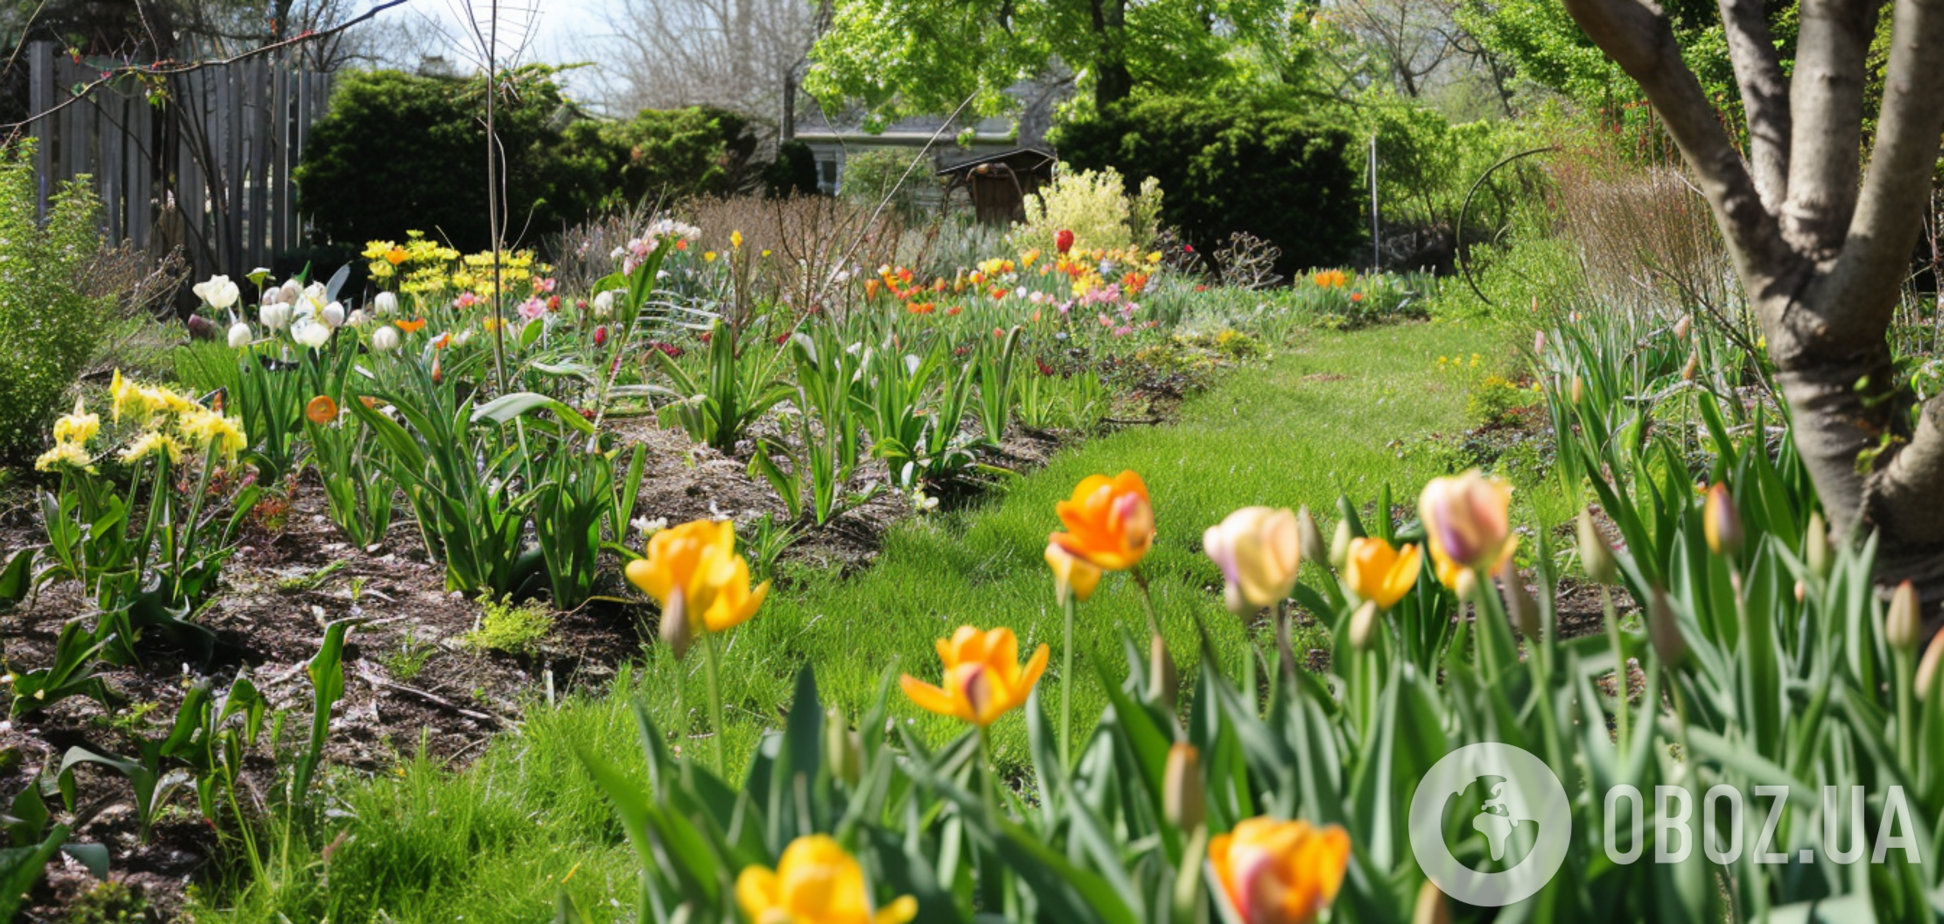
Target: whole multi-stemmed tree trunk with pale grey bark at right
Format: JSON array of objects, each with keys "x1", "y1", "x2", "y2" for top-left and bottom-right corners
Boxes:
[{"x1": 1565, "y1": 0, "x2": 1944, "y2": 605}]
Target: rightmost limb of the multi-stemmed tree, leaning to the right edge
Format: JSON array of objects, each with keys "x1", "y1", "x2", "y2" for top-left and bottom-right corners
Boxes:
[{"x1": 1825, "y1": 0, "x2": 1944, "y2": 337}]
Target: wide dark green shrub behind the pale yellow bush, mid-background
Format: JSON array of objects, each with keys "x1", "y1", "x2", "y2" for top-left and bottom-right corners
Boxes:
[{"x1": 1054, "y1": 97, "x2": 1367, "y2": 276}]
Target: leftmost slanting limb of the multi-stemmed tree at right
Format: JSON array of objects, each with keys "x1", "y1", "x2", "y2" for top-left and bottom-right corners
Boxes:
[{"x1": 1565, "y1": 0, "x2": 1796, "y2": 292}]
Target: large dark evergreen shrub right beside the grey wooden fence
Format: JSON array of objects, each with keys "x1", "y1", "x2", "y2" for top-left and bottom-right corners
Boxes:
[{"x1": 295, "y1": 66, "x2": 612, "y2": 251}]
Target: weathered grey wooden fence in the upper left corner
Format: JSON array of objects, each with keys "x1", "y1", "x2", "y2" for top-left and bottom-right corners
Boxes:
[{"x1": 29, "y1": 43, "x2": 330, "y2": 278}]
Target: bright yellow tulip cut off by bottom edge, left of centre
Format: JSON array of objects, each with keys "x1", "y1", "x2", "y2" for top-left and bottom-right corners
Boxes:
[{"x1": 735, "y1": 835, "x2": 918, "y2": 924}]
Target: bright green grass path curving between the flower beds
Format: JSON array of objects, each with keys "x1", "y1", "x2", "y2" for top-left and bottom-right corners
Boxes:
[{"x1": 205, "y1": 323, "x2": 1503, "y2": 922}]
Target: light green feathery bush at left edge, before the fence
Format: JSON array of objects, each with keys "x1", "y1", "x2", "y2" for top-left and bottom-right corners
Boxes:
[{"x1": 0, "y1": 146, "x2": 113, "y2": 461}]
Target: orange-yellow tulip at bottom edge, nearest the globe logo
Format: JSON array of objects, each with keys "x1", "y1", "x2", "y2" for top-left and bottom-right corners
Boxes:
[{"x1": 1209, "y1": 817, "x2": 1349, "y2": 924}]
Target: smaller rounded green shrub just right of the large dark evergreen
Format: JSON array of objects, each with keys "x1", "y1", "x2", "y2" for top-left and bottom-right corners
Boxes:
[{"x1": 566, "y1": 107, "x2": 758, "y2": 207}]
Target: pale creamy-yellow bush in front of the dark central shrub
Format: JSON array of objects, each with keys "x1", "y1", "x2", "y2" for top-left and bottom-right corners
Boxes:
[{"x1": 1009, "y1": 163, "x2": 1163, "y2": 255}]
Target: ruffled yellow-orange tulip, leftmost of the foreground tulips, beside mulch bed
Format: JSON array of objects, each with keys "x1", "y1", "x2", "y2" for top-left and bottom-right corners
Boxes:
[{"x1": 628, "y1": 519, "x2": 770, "y2": 632}]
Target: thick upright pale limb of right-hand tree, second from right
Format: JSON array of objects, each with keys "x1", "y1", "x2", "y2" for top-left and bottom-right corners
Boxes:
[{"x1": 1783, "y1": 0, "x2": 1874, "y2": 259}]
